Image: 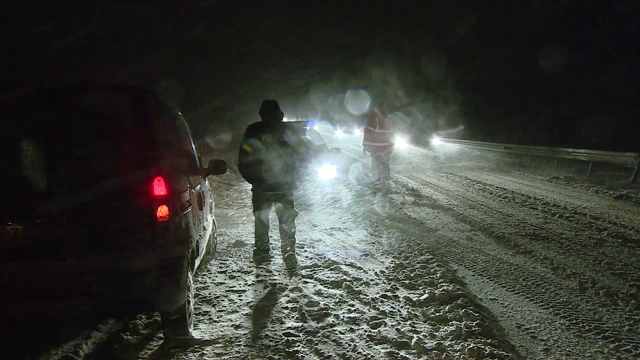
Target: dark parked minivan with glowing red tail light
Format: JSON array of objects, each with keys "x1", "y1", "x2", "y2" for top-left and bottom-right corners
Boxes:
[{"x1": 0, "y1": 85, "x2": 227, "y2": 338}]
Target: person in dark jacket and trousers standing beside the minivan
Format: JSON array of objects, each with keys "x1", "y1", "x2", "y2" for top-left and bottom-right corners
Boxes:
[{"x1": 238, "y1": 100, "x2": 302, "y2": 269}]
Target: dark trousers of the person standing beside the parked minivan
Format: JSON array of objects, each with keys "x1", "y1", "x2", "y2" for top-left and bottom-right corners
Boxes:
[{"x1": 252, "y1": 191, "x2": 298, "y2": 255}]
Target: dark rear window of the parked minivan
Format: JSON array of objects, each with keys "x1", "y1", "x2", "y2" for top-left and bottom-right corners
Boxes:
[{"x1": 0, "y1": 91, "x2": 155, "y2": 220}]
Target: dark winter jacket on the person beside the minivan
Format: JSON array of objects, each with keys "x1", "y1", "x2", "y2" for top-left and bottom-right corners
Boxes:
[{"x1": 238, "y1": 120, "x2": 302, "y2": 192}]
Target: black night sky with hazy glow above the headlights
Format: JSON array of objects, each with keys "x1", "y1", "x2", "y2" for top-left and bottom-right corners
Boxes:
[{"x1": 0, "y1": 0, "x2": 640, "y2": 152}]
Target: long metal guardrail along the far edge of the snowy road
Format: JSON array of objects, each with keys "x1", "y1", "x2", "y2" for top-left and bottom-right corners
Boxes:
[{"x1": 441, "y1": 138, "x2": 640, "y2": 183}]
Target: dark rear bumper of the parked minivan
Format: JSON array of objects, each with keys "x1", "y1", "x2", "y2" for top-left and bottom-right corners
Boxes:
[{"x1": 0, "y1": 245, "x2": 187, "y2": 318}]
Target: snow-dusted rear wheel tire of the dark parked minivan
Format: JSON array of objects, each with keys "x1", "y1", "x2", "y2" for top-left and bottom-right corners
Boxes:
[{"x1": 160, "y1": 262, "x2": 195, "y2": 340}]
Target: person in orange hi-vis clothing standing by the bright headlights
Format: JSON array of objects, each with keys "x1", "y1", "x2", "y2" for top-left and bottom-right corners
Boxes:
[{"x1": 362, "y1": 108, "x2": 394, "y2": 191}]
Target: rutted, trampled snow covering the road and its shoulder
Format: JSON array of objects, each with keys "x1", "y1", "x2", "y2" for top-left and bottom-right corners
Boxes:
[{"x1": 28, "y1": 138, "x2": 640, "y2": 359}]
